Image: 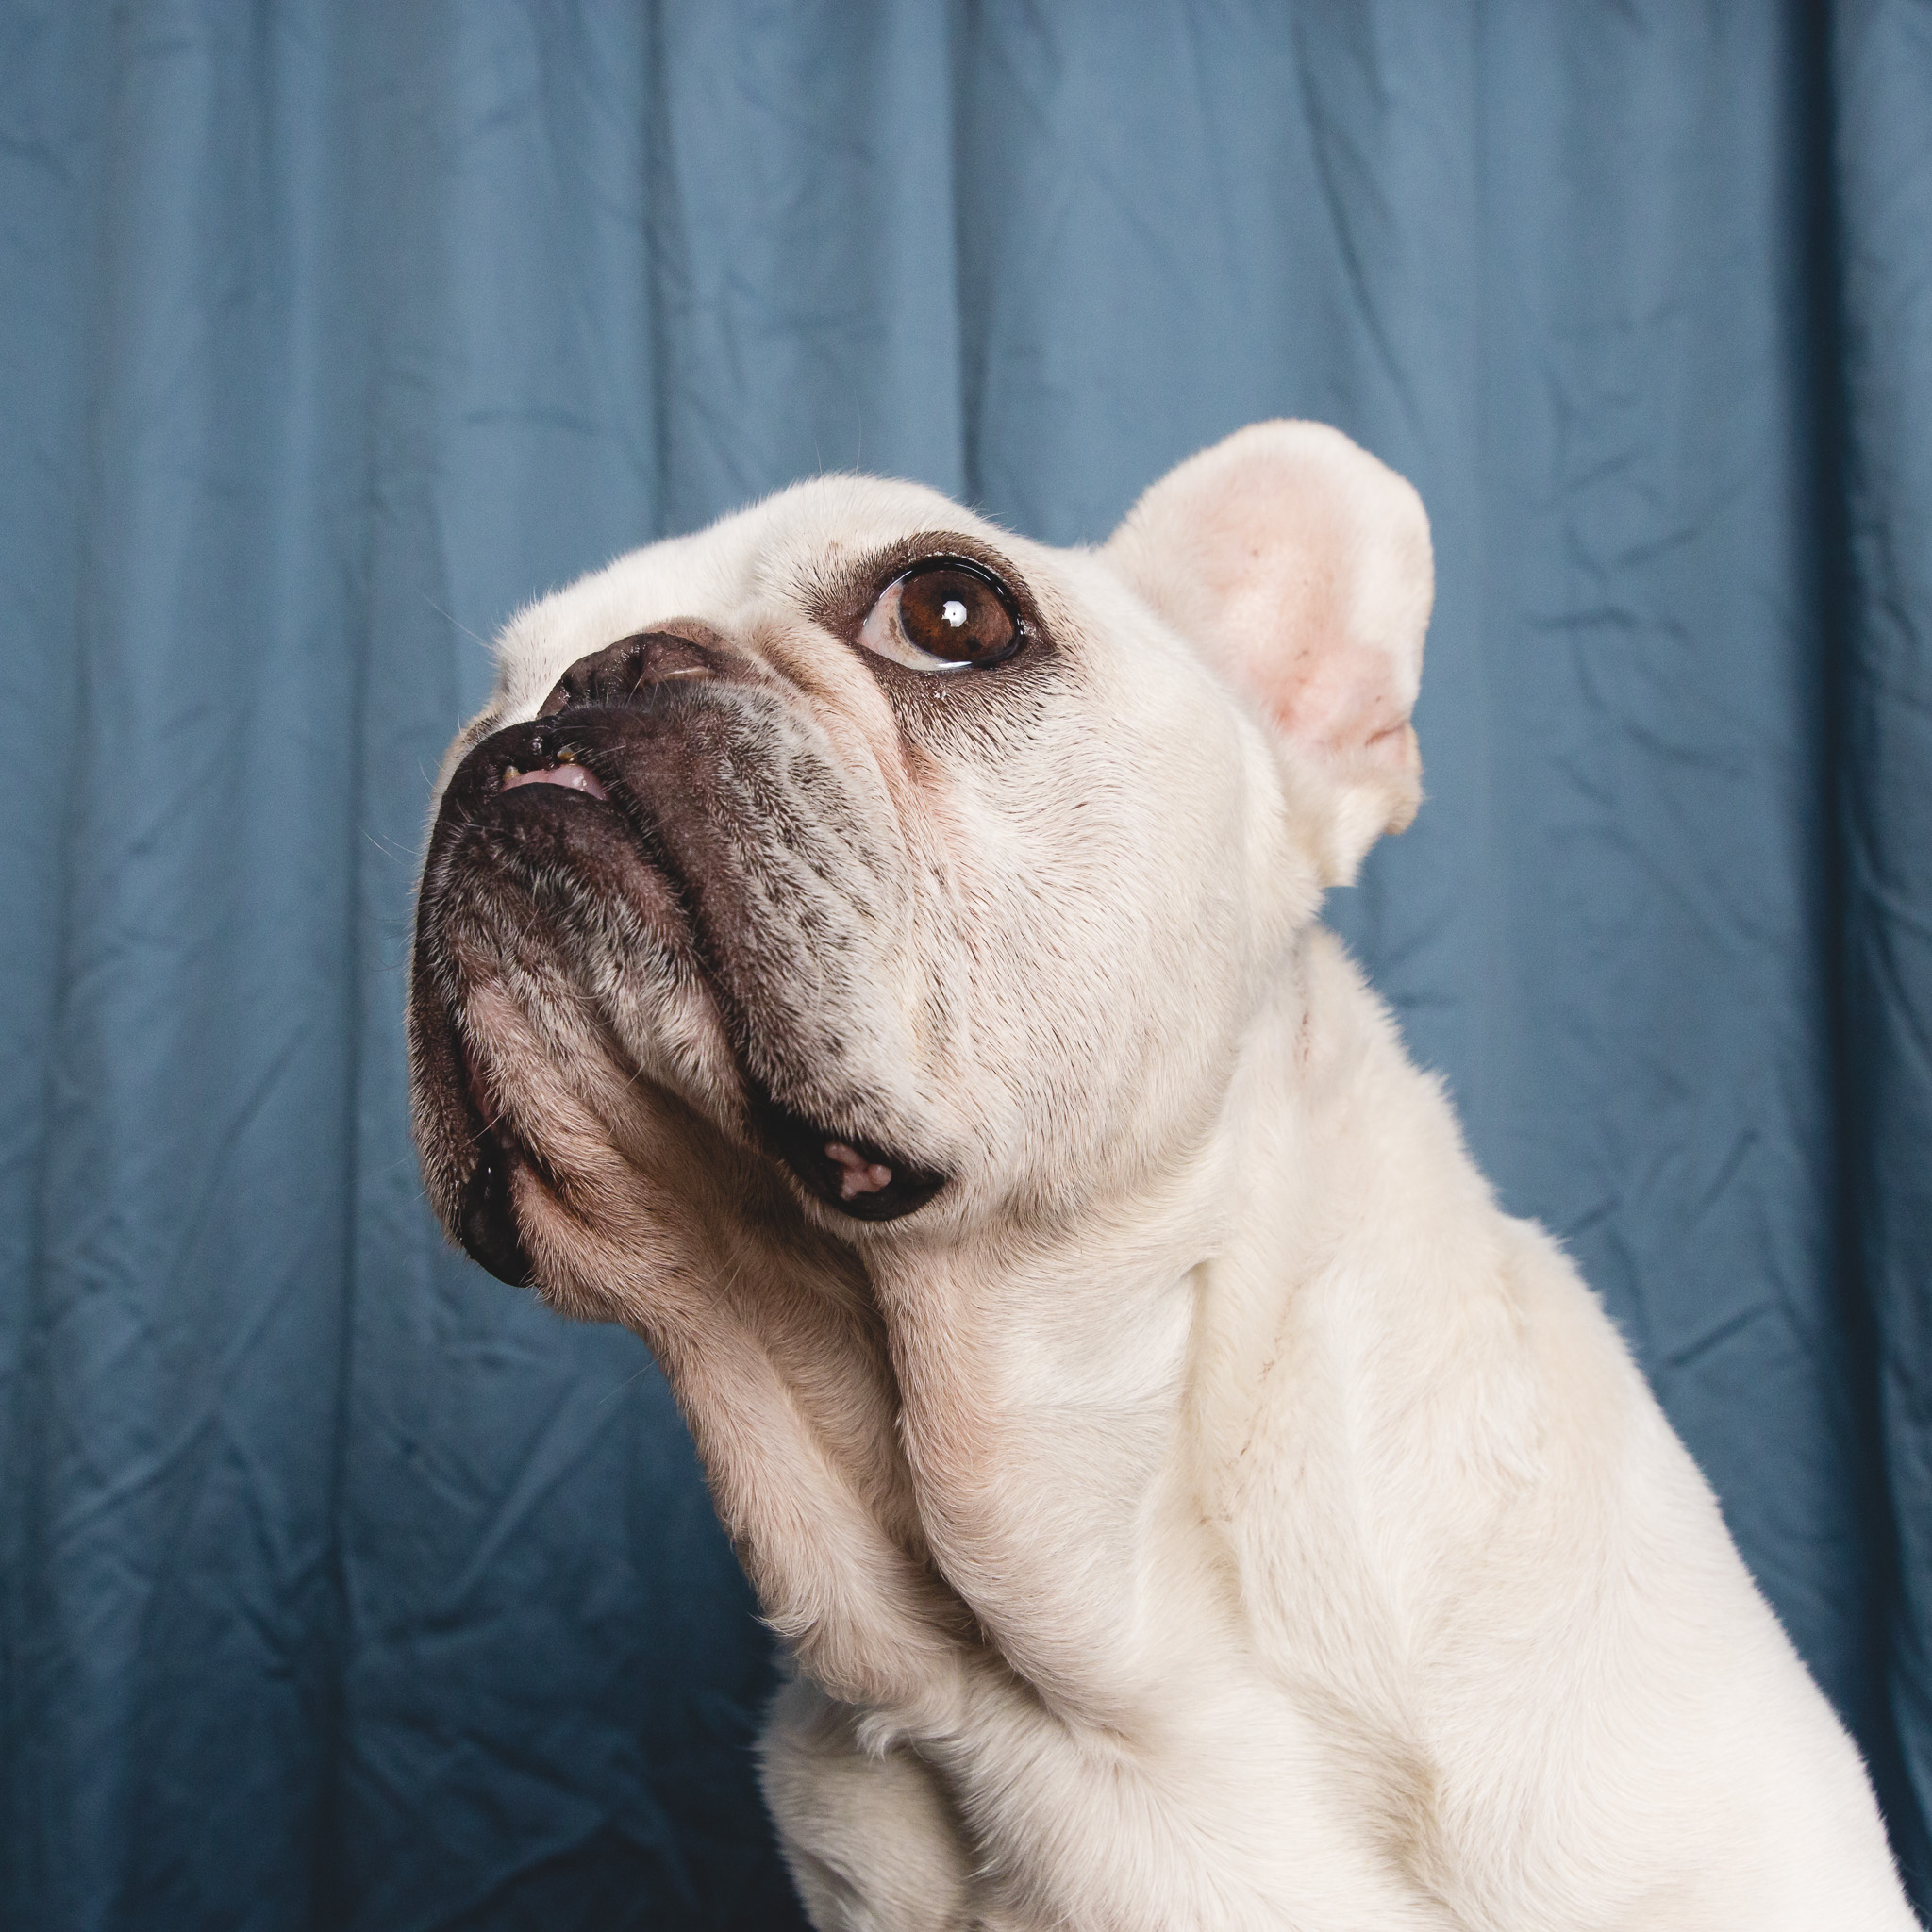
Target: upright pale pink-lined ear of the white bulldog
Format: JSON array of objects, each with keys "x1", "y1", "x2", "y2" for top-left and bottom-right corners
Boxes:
[{"x1": 1108, "y1": 424, "x2": 1436, "y2": 885}]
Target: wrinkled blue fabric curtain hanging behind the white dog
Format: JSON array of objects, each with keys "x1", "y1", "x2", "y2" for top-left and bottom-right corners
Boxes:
[{"x1": 0, "y1": 0, "x2": 1932, "y2": 1932}]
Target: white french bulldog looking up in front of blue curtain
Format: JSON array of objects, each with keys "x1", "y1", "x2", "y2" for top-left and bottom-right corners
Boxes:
[{"x1": 409, "y1": 424, "x2": 1917, "y2": 1932}]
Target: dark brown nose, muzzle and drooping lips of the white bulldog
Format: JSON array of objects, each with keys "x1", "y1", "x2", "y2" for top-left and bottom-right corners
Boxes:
[{"x1": 409, "y1": 625, "x2": 944, "y2": 1285}]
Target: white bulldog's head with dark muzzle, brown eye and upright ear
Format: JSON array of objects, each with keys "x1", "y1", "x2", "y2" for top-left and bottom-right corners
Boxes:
[{"x1": 409, "y1": 424, "x2": 1432, "y2": 1289}]
